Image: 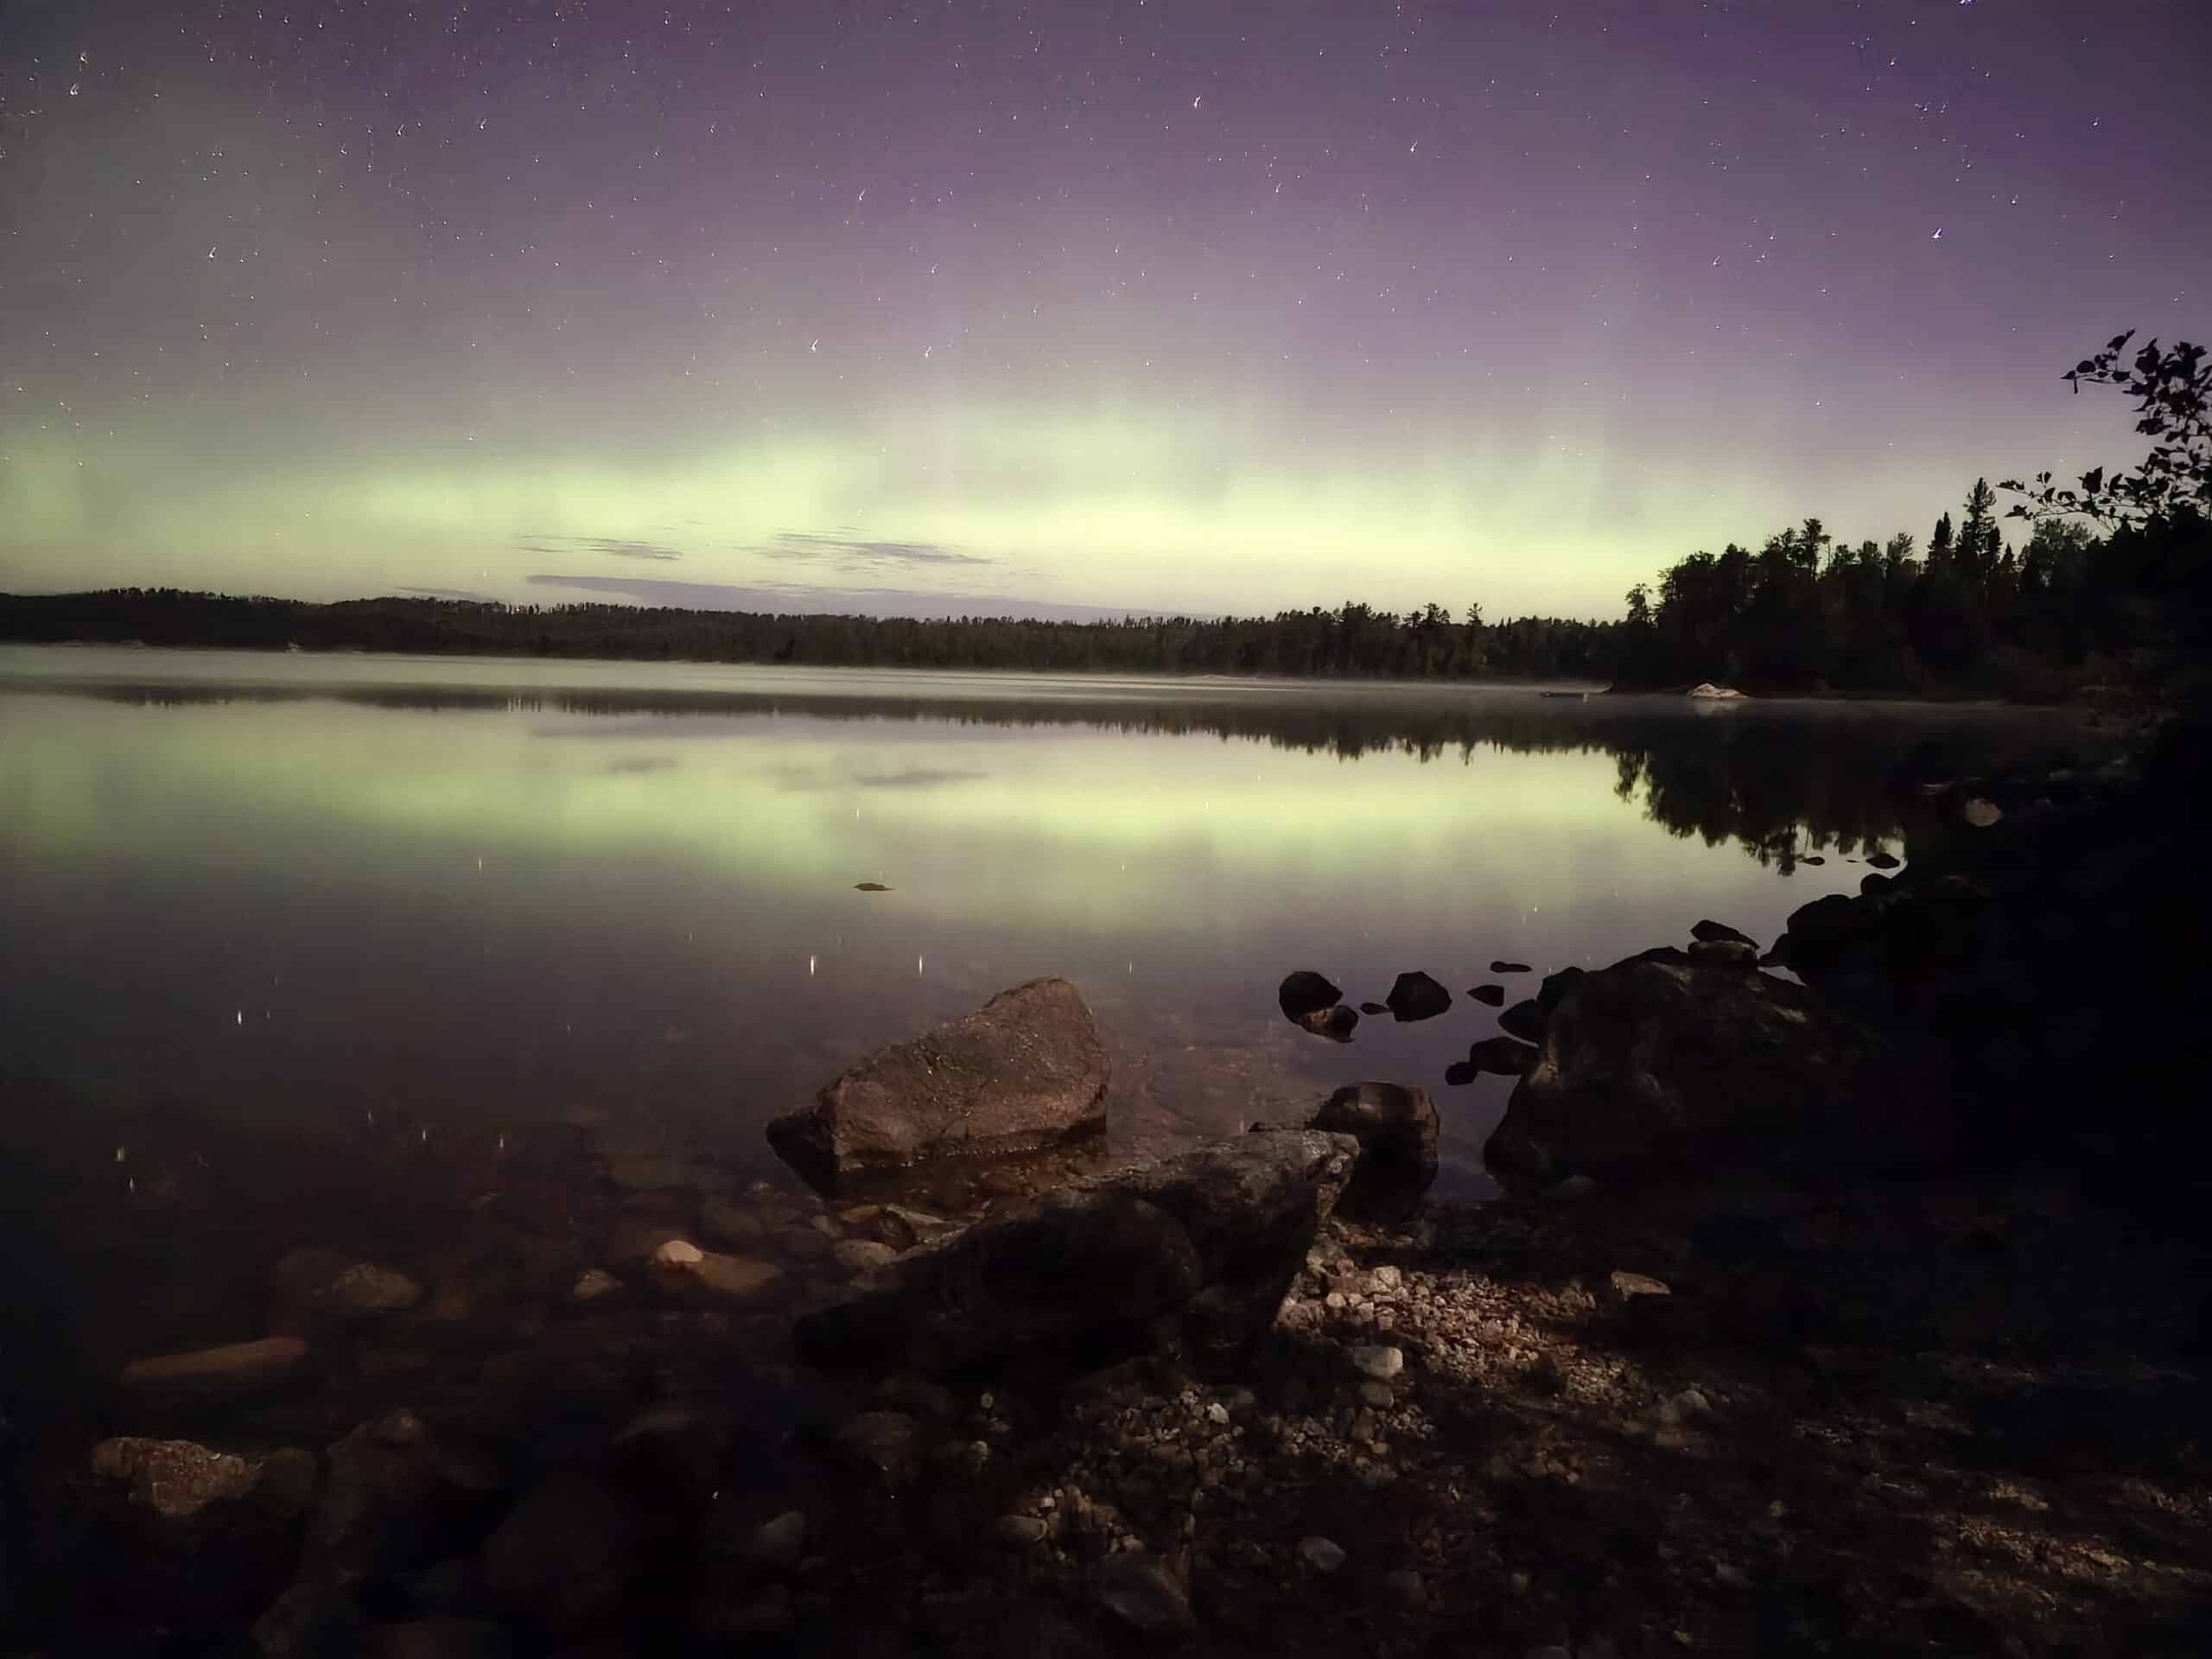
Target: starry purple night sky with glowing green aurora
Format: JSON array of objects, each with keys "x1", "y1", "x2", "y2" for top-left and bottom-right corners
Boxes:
[{"x1": 0, "y1": 0, "x2": 2212, "y2": 617}]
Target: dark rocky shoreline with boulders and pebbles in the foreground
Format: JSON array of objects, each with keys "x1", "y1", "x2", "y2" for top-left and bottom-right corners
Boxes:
[{"x1": 0, "y1": 728, "x2": 2212, "y2": 1659}]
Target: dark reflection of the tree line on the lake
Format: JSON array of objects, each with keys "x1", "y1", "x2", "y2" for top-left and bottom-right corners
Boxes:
[{"x1": 39, "y1": 683, "x2": 2079, "y2": 869}]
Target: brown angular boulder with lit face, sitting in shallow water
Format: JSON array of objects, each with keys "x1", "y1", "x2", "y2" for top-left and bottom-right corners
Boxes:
[{"x1": 767, "y1": 978, "x2": 1109, "y2": 1192}]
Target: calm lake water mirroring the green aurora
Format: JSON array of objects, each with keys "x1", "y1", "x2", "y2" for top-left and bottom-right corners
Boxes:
[{"x1": 0, "y1": 648, "x2": 2088, "y2": 1194}]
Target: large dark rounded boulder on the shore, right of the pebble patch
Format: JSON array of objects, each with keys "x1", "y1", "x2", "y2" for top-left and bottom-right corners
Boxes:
[{"x1": 1484, "y1": 951, "x2": 1944, "y2": 1190}]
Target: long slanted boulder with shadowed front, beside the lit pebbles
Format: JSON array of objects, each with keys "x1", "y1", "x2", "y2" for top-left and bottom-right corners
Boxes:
[{"x1": 797, "y1": 1133, "x2": 1358, "y2": 1374}]
